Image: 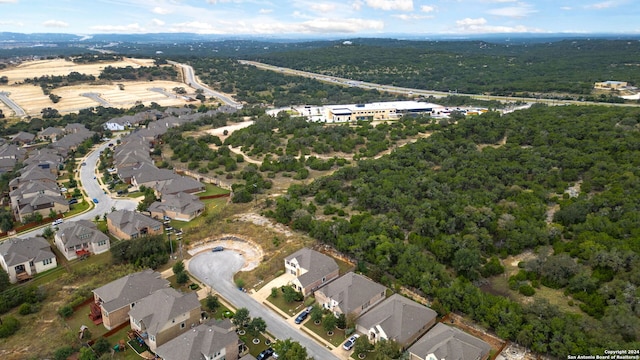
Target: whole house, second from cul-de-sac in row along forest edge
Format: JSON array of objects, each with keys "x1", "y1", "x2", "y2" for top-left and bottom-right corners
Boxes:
[{"x1": 315, "y1": 272, "x2": 387, "y2": 317}]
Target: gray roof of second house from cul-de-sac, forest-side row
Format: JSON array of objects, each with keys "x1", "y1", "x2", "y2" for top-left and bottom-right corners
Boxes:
[{"x1": 318, "y1": 272, "x2": 387, "y2": 314}]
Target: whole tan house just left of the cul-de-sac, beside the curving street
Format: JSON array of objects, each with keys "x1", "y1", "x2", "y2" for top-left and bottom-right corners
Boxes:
[{"x1": 107, "y1": 210, "x2": 162, "y2": 240}]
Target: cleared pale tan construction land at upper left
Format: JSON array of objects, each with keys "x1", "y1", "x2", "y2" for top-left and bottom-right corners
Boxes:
[{"x1": 0, "y1": 58, "x2": 195, "y2": 116}]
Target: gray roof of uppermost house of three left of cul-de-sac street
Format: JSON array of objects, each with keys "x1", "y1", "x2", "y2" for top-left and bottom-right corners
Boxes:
[{"x1": 93, "y1": 269, "x2": 169, "y2": 312}]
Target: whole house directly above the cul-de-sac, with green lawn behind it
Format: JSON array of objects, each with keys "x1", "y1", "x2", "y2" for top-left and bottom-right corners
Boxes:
[{"x1": 149, "y1": 192, "x2": 204, "y2": 221}]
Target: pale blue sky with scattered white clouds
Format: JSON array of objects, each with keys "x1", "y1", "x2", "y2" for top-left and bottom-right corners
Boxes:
[{"x1": 0, "y1": 0, "x2": 640, "y2": 36}]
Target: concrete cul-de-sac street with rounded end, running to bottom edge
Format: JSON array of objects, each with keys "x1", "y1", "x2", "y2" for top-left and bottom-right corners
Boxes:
[{"x1": 188, "y1": 250, "x2": 338, "y2": 360}]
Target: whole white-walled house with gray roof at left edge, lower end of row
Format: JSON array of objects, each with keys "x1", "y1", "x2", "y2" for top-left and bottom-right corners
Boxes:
[{"x1": 0, "y1": 237, "x2": 58, "y2": 283}]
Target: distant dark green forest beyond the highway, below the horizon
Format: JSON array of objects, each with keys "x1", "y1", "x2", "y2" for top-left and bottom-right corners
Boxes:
[{"x1": 251, "y1": 39, "x2": 640, "y2": 96}]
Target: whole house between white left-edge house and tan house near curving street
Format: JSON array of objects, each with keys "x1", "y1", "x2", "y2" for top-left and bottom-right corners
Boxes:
[{"x1": 54, "y1": 220, "x2": 110, "y2": 260}]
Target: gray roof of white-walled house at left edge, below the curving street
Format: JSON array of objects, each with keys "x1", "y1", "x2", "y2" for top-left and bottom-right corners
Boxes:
[{"x1": 0, "y1": 237, "x2": 56, "y2": 266}]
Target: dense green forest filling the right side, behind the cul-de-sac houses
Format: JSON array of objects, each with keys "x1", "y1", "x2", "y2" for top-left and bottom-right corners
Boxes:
[{"x1": 267, "y1": 106, "x2": 640, "y2": 357}]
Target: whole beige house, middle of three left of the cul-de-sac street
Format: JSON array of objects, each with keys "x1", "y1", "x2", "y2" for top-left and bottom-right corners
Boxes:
[{"x1": 129, "y1": 288, "x2": 201, "y2": 352}]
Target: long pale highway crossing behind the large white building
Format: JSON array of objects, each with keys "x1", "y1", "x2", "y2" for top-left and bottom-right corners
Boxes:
[{"x1": 238, "y1": 60, "x2": 640, "y2": 107}]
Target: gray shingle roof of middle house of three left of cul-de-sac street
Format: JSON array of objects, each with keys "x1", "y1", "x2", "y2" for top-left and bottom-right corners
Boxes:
[{"x1": 129, "y1": 288, "x2": 200, "y2": 336}]
